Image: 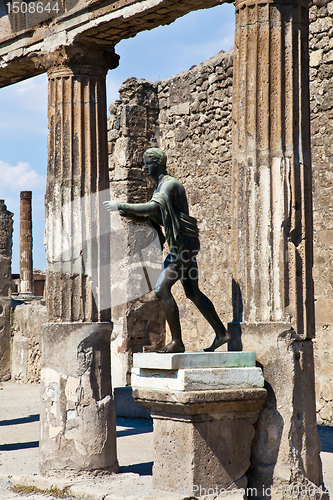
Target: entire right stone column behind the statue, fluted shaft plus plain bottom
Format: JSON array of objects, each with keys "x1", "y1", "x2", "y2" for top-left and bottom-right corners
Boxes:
[{"x1": 230, "y1": 0, "x2": 322, "y2": 494}]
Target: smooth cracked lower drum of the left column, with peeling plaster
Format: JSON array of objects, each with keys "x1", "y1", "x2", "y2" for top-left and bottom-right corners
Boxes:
[{"x1": 40, "y1": 323, "x2": 118, "y2": 474}]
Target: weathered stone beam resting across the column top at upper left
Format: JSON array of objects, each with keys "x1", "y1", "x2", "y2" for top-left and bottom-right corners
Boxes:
[{"x1": 0, "y1": 0, "x2": 233, "y2": 86}]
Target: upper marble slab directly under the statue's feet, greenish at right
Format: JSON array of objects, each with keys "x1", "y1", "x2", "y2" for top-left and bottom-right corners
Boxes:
[{"x1": 133, "y1": 351, "x2": 256, "y2": 370}]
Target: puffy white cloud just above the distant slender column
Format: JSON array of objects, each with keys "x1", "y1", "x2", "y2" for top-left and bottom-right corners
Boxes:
[{"x1": 0, "y1": 160, "x2": 45, "y2": 198}]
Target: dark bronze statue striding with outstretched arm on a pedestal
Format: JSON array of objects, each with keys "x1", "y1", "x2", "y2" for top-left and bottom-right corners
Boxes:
[{"x1": 104, "y1": 148, "x2": 232, "y2": 352}]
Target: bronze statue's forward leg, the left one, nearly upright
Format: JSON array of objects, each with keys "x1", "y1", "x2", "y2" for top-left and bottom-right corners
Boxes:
[{"x1": 155, "y1": 255, "x2": 185, "y2": 352}]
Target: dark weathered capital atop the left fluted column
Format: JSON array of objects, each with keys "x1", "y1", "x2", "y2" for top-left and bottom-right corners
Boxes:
[{"x1": 31, "y1": 42, "x2": 120, "y2": 77}]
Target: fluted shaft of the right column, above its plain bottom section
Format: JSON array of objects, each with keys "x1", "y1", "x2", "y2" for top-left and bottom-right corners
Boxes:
[{"x1": 233, "y1": 0, "x2": 314, "y2": 338}]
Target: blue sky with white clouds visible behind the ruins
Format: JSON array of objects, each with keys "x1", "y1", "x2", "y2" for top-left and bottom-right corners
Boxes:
[{"x1": 0, "y1": 4, "x2": 234, "y2": 273}]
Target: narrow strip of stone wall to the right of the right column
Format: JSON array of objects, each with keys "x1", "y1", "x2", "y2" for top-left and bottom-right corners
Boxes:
[{"x1": 309, "y1": 1, "x2": 333, "y2": 425}]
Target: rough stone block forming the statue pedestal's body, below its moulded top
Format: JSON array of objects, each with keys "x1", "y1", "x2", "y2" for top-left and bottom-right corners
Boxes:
[{"x1": 153, "y1": 415, "x2": 257, "y2": 491}]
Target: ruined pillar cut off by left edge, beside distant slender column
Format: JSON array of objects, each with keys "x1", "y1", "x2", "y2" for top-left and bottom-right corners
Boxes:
[{"x1": 0, "y1": 200, "x2": 13, "y2": 381}]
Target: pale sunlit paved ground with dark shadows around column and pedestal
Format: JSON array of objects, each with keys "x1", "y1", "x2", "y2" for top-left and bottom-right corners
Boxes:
[{"x1": 0, "y1": 382, "x2": 333, "y2": 500}]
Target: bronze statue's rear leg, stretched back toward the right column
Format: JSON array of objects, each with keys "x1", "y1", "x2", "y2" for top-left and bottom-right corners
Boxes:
[{"x1": 181, "y1": 257, "x2": 232, "y2": 351}]
